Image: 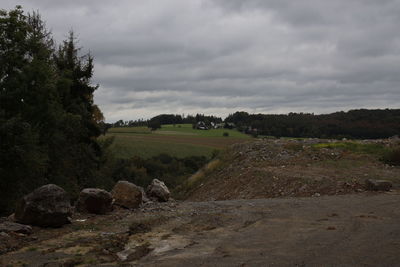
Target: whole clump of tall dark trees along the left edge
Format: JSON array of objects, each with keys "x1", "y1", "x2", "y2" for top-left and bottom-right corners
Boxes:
[{"x1": 0, "y1": 6, "x2": 109, "y2": 213}]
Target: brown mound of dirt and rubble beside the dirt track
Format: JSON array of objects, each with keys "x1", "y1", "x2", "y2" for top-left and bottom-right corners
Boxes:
[{"x1": 183, "y1": 139, "x2": 400, "y2": 201}]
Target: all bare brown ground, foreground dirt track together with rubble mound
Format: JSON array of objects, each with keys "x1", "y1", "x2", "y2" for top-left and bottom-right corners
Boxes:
[{"x1": 0, "y1": 139, "x2": 400, "y2": 267}]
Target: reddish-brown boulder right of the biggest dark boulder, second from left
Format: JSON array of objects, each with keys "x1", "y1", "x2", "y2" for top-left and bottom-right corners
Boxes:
[{"x1": 76, "y1": 188, "x2": 113, "y2": 214}]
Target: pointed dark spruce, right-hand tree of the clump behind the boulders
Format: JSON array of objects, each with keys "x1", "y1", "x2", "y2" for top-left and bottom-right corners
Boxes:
[{"x1": 50, "y1": 32, "x2": 103, "y2": 193}]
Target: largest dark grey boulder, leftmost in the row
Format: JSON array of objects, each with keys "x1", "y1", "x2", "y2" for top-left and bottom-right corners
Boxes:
[{"x1": 15, "y1": 184, "x2": 72, "y2": 227}]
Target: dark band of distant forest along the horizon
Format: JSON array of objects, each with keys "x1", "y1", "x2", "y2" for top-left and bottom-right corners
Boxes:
[{"x1": 111, "y1": 109, "x2": 400, "y2": 139}]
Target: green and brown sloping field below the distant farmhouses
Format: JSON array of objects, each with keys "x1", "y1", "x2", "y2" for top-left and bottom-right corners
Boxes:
[{"x1": 106, "y1": 124, "x2": 251, "y2": 158}]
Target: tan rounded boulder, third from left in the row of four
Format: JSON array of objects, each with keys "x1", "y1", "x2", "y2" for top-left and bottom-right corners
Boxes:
[{"x1": 111, "y1": 181, "x2": 142, "y2": 209}]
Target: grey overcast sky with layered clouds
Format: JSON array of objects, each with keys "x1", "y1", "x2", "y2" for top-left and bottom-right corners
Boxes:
[{"x1": 0, "y1": 0, "x2": 400, "y2": 122}]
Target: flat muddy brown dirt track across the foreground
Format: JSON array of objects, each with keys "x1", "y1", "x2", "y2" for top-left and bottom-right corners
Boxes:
[{"x1": 0, "y1": 194, "x2": 400, "y2": 266}]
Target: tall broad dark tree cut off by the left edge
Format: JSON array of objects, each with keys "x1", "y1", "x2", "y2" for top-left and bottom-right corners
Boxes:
[{"x1": 0, "y1": 6, "x2": 57, "y2": 214}]
